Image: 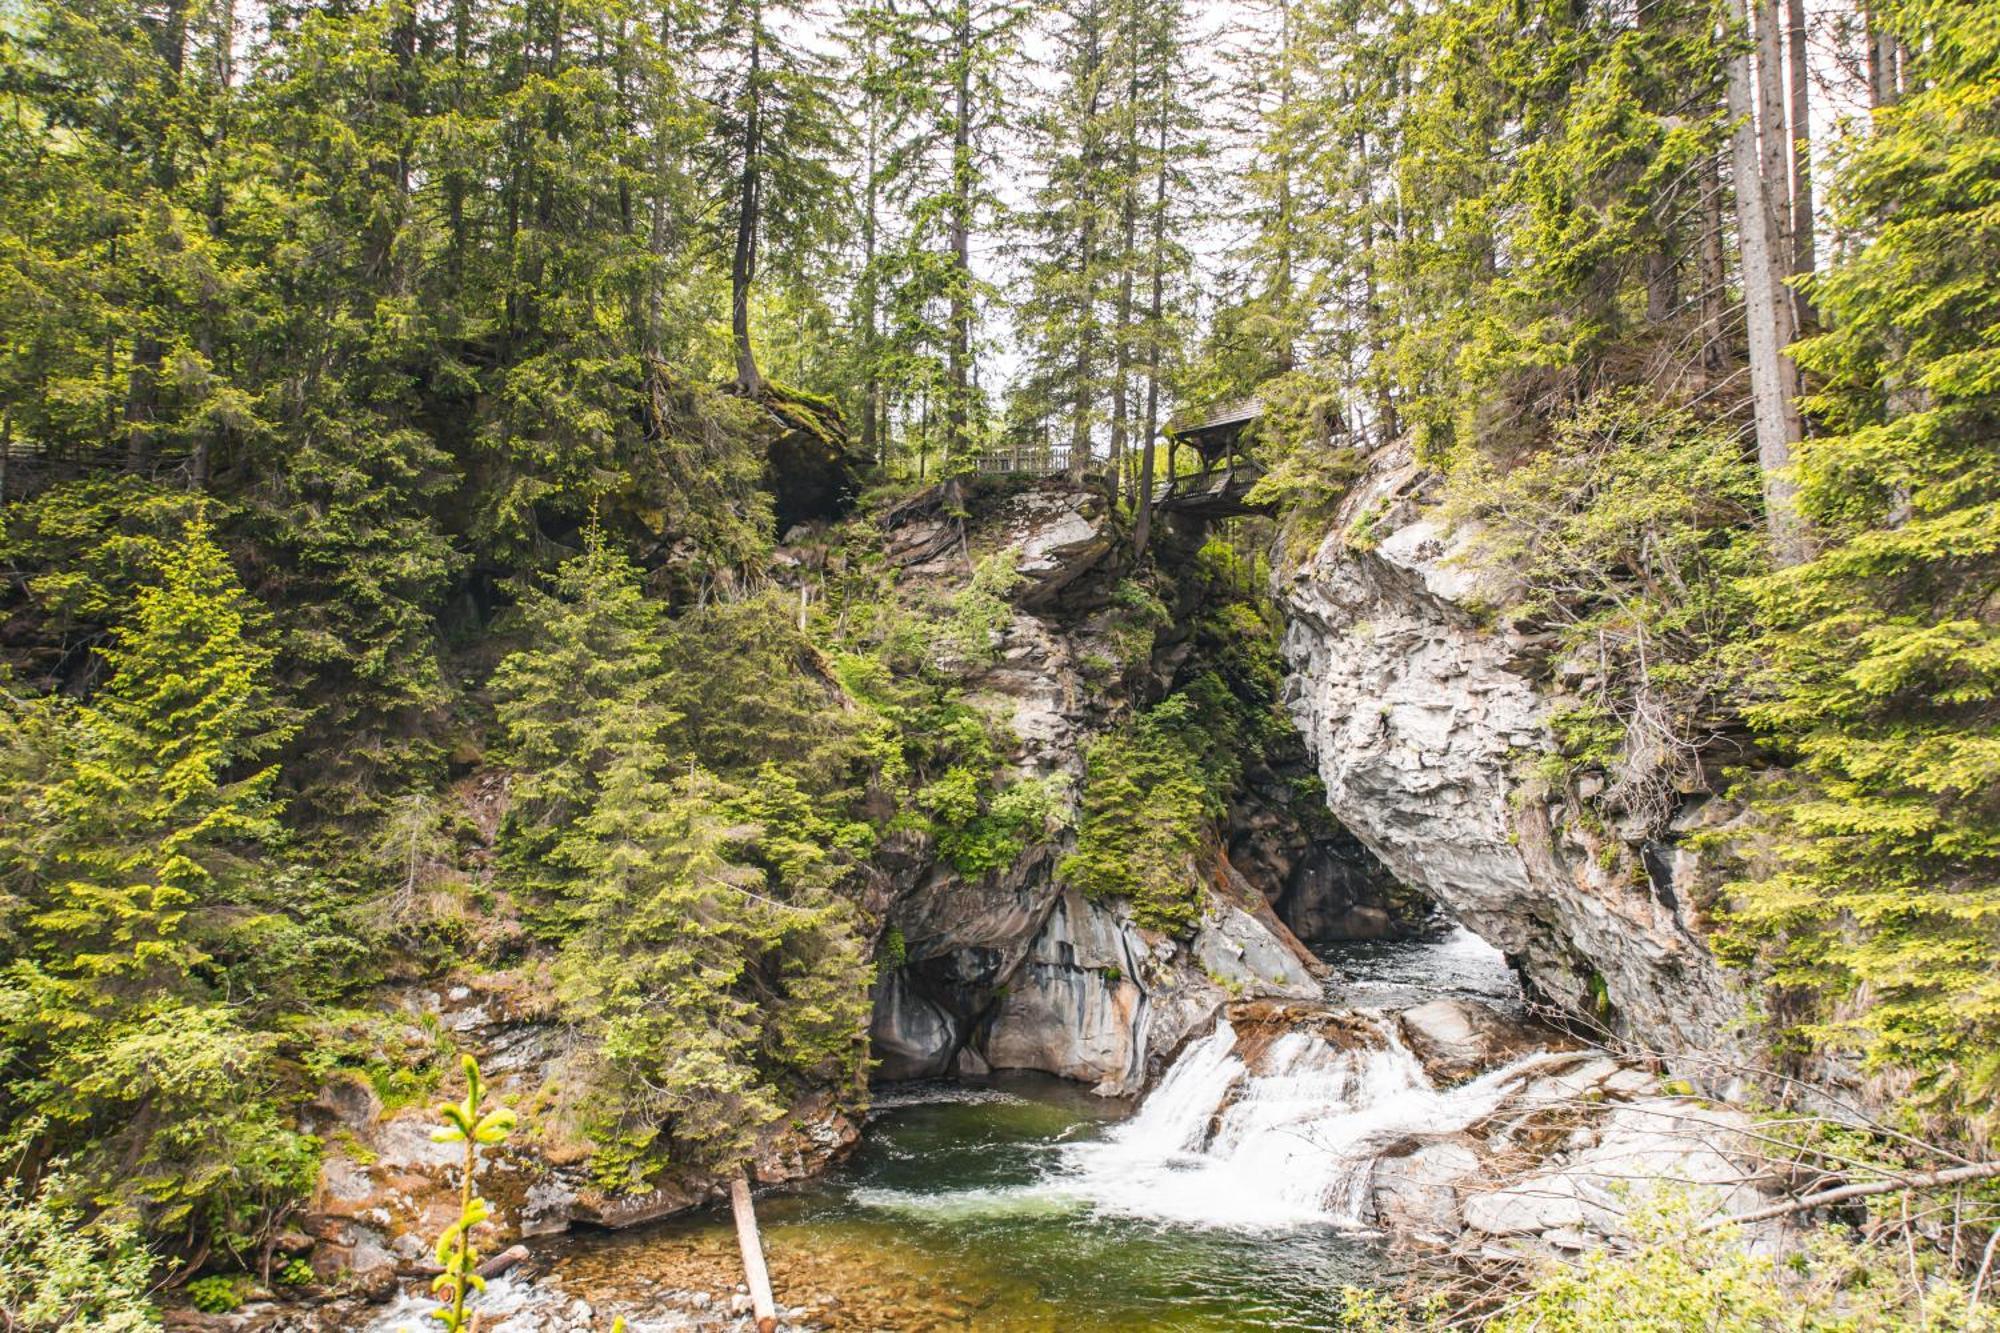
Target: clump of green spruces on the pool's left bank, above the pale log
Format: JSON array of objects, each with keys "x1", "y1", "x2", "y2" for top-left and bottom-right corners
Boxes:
[{"x1": 492, "y1": 538, "x2": 872, "y2": 1181}]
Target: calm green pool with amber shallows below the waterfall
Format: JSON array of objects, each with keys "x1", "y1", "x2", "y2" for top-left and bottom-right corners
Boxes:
[{"x1": 556, "y1": 1079, "x2": 1382, "y2": 1333}]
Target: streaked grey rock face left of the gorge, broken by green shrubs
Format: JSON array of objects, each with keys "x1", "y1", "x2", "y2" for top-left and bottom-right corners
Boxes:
[{"x1": 872, "y1": 480, "x2": 1328, "y2": 1095}]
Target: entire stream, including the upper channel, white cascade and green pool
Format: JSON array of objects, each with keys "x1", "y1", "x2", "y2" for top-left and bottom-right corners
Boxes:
[{"x1": 372, "y1": 931, "x2": 1532, "y2": 1333}]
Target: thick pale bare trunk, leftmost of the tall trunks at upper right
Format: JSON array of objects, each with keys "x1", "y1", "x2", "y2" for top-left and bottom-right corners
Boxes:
[{"x1": 1728, "y1": 0, "x2": 1806, "y2": 564}]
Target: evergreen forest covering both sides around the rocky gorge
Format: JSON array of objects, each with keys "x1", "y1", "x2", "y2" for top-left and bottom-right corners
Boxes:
[{"x1": 0, "y1": 0, "x2": 2000, "y2": 1312}]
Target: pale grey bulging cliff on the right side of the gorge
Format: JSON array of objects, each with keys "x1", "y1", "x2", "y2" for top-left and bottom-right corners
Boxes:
[{"x1": 1278, "y1": 450, "x2": 1742, "y2": 1053}]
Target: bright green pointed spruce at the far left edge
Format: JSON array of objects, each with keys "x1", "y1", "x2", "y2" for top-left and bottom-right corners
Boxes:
[{"x1": 0, "y1": 518, "x2": 318, "y2": 1243}]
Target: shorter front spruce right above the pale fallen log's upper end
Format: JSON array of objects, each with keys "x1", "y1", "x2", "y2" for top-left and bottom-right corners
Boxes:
[{"x1": 556, "y1": 764, "x2": 866, "y2": 1167}]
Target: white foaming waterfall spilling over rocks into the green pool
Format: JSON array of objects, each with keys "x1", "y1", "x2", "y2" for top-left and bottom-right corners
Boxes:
[{"x1": 1060, "y1": 1019, "x2": 1548, "y2": 1229}]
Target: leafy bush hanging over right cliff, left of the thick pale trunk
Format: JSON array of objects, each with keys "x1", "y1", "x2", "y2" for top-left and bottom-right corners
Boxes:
[{"x1": 1446, "y1": 392, "x2": 1764, "y2": 825}]
